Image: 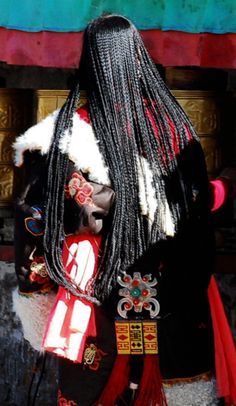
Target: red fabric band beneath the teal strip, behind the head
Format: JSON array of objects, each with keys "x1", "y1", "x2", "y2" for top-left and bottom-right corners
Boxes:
[{"x1": 0, "y1": 28, "x2": 236, "y2": 68}]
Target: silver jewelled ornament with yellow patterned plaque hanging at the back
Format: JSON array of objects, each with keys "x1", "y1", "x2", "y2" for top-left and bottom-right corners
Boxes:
[{"x1": 115, "y1": 272, "x2": 160, "y2": 355}]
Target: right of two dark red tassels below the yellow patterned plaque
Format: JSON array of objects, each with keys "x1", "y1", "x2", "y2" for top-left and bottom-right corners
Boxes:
[{"x1": 135, "y1": 355, "x2": 167, "y2": 406}]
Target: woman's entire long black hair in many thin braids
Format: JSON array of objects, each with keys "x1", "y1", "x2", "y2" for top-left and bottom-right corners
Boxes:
[{"x1": 44, "y1": 15, "x2": 211, "y2": 300}]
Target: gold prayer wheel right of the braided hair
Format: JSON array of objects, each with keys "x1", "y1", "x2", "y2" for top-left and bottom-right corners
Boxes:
[{"x1": 172, "y1": 90, "x2": 221, "y2": 176}]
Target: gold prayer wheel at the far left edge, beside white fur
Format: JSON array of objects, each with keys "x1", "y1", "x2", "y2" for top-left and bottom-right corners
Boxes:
[{"x1": 0, "y1": 89, "x2": 32, "y2": 210}]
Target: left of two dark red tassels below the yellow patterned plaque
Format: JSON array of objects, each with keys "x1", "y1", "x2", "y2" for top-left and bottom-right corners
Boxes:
[{"x1": 96, "y1": 355, "x2": 130, "y2": 406}]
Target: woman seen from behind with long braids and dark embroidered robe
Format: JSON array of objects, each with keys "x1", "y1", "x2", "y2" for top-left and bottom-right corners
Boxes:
[{"x1": 15, "y1": 15, "x2": 236, "y2": 406}]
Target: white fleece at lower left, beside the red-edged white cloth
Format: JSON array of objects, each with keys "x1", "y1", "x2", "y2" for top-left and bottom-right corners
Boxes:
[{"x1": 12, "y1": 289, "x2": 56, "y2": 351}]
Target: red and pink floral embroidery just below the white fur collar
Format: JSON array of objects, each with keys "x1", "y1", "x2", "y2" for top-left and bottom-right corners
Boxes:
[{"x1": 65, "y1": 172, "x2": 93, "y2": 206}]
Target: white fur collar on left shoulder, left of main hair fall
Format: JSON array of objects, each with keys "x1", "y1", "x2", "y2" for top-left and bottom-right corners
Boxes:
[{"x1": 13, "y1": 110, "x2": 110, "y2": 186}]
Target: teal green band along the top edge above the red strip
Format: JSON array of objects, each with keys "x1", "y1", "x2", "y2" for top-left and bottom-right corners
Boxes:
[{"x1": 0, "y1": 0, "x2": 236, "y2": 33}]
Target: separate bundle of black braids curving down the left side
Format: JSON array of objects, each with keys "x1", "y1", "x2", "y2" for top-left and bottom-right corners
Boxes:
[{"x1": 44, "y1": 84, "x2": 100, "y2": 301}]
